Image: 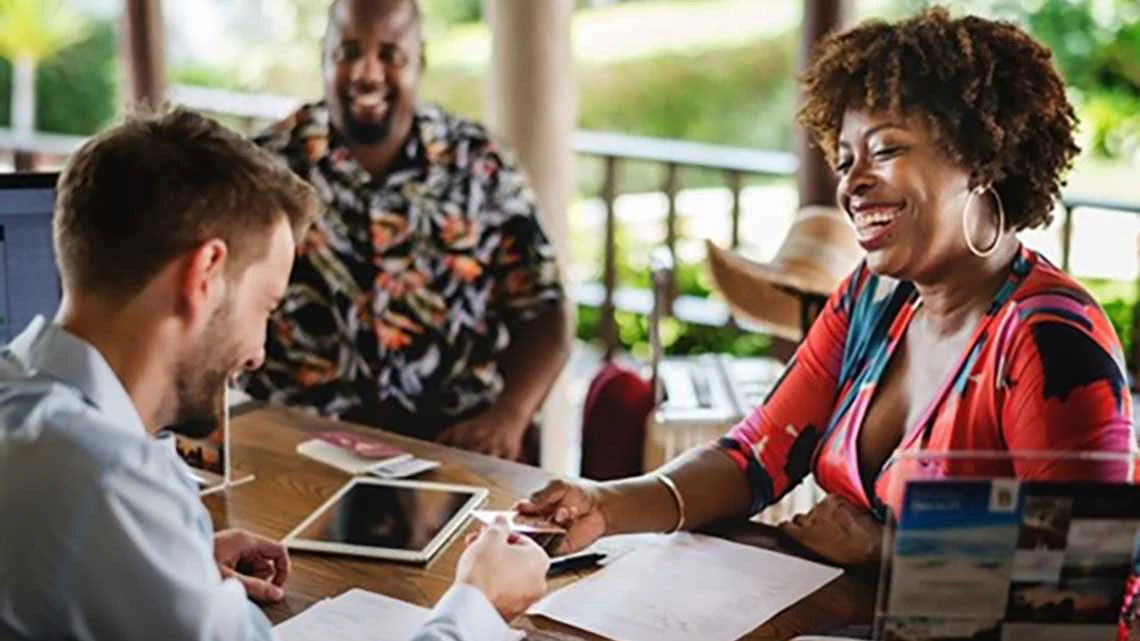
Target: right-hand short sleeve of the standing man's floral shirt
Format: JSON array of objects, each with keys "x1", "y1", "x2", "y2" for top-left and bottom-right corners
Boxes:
[{"x1": 487, "y1": 145, "x2": 563, "y2": 322}]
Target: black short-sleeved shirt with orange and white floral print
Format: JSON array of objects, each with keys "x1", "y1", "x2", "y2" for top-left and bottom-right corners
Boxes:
[{"x1": 245, "y1": 103, "x2": 563, "y2": 438}]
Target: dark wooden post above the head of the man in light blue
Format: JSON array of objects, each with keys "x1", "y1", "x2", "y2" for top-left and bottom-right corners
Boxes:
[{"x1": 122, "y1": 0, "x2": 165, "y2": 107}]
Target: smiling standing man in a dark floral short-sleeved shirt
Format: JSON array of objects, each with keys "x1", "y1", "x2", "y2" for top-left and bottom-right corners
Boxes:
[{"x1": 246, "y1": 0, "x2": 569, "y2": 461}]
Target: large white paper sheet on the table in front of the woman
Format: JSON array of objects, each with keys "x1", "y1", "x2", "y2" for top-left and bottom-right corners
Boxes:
[{"x1": 529, "y1": 526, "x2": 842, "y2": 641}]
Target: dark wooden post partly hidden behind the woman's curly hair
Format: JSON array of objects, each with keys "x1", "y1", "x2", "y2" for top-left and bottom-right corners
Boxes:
[{"x1": 796, "y1": 0, "x2": 850, "y2": 208}]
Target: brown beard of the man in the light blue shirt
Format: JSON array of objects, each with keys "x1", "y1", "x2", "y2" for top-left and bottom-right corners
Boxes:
[{"x1": 166, "y1": 301, "x2": 236, "y2": 439}]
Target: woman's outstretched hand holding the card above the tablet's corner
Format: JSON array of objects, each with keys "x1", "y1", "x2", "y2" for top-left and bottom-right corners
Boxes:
[{"x1": 514, "y1": 480, "x2": 608, "y2": 555}]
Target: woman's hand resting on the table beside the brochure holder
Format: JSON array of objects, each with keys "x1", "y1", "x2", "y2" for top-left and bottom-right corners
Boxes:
[{"x1": 780, "y1": 495, "x2": 882, "y2": 567}]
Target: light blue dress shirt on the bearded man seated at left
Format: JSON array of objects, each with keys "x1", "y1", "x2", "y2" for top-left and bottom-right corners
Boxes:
[{"x1": 0, "y1": 318, "x2": 507, "y2": 641}]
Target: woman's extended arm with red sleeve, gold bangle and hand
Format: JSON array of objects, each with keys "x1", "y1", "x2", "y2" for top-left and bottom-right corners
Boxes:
[{"x1": 518, "y1": 267, "x2": 865, "y2": 552}]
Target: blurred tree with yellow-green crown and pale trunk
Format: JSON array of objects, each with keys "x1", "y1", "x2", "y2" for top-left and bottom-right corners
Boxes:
[{"x1": 0, "y1": 0, "x2": 87, "y2": 135}]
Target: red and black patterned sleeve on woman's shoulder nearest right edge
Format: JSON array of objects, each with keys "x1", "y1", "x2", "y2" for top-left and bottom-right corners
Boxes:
[{"x1": 998, "y1": 297, "x2": 1135, "y2": 481}]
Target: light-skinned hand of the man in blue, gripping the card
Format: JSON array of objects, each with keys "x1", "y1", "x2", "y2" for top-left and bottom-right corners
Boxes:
[{"x1": 455, "y1": 517, "x2": 551, "y2": 622}]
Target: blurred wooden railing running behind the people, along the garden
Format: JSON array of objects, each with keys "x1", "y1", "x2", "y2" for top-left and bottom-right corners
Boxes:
[{"x1": 0, "y1": 86, "x2": 1140, "y2": 380}]
